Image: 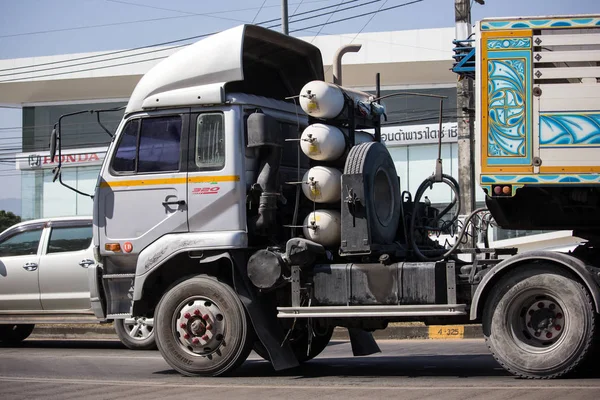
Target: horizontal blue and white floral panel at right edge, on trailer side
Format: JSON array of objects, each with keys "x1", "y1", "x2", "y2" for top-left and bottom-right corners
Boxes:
[{"x1": 540, "y1": 112, "x2": 600, "y2": 147}]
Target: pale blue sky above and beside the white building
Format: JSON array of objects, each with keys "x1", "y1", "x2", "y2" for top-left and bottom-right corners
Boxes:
[{"x1": 0, "y1": 0, "x2": 600, "y2": 212}]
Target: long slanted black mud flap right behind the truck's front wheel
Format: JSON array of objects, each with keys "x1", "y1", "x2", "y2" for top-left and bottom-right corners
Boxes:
[{"x1": 231, "y1": 254, "x2": 300, "y2": 371}]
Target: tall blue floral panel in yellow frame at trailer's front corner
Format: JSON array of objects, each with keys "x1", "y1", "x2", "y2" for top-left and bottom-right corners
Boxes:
[{"x1": 482, "y1": 43, "x2": 532, "y2": 167}]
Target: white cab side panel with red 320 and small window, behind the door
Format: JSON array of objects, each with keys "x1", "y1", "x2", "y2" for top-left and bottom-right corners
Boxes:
[{"x1": 187, "y1": 106, "x2": 246, "y2": 236}]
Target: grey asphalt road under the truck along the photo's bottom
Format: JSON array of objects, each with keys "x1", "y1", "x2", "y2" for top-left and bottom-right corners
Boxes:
[{"x1": 0, "y1": 340, "x2": 600, "y2": 400}]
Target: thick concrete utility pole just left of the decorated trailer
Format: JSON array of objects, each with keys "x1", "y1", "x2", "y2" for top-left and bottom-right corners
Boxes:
[{"x1": 454, "y1": 0, "x2": 479, "y2": 246}]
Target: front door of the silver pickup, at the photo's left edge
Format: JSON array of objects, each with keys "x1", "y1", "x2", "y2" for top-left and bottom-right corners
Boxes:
[{"x1": 0, "y1": 224, "x2": 44, "y2": 311}]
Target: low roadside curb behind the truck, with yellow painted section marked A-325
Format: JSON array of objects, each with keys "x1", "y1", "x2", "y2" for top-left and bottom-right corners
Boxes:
[{"x1": 30, "y1": 323, "x2": 483, "y2": 340}]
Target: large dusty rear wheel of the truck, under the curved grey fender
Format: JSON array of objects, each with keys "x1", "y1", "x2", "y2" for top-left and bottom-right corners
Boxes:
[{"x1": 482, "y1": 265, "x2": 595, "y2": 379}]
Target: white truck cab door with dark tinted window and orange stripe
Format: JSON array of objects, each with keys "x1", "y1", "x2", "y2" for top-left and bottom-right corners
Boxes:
[{"x1": 95, "y1": 109, "x2": 189, "y2": 260}]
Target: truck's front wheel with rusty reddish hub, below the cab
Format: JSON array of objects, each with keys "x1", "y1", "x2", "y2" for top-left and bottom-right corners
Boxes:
[{"x1": 154, "y1": 275, "x2": 254, "y2": 376}]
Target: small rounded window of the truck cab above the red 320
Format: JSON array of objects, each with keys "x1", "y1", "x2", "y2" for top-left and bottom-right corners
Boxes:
[{"x1": 195, "y1": 113, "x2": 225, "y2": 171}]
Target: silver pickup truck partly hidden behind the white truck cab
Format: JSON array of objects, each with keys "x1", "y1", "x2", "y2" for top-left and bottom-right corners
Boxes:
[{"x1": 0, "y1": 217, "x2": 155, "y2": 349}]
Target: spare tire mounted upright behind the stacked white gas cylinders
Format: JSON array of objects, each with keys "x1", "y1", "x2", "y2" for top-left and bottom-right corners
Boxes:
[{"x1": 344, "y1": 142, "x2": 401, "y2": 244}]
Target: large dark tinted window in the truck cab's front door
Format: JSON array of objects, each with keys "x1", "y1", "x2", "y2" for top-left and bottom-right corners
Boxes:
[{"x1": 112, "y1": 115, "x2": 182, "y2": 173}]
